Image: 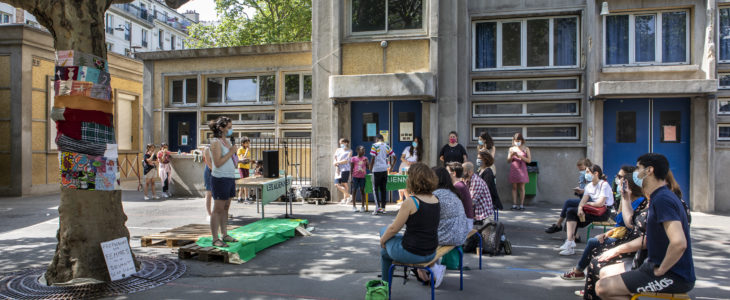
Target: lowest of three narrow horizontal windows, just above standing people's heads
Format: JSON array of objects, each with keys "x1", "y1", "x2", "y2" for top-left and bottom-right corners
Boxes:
[{"x1": 472, "y1": 124, "x2": 579, "y2": 141}]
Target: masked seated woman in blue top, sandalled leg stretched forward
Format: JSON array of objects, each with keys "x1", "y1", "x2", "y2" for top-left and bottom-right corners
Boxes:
[{"x1": 560, "y1": 166, "x2": 646, "y2": 280}]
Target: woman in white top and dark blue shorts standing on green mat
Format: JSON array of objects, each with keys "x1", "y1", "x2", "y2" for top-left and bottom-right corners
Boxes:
[{"x1": 208, "y1": 117, "x2": 240, "y2": 247}]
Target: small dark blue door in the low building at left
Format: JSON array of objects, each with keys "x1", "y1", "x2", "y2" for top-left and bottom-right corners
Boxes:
[{"x1": 167, "y1": 112, "x2": 198, "y2": 152}]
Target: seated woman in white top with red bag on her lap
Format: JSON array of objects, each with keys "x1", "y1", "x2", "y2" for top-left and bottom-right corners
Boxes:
[{"x1": 560, "y1": 165, "x2": 613, "y2": 255}]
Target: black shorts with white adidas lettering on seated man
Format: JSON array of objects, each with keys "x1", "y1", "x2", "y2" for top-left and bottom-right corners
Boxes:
[{"x1": 621, "y1": 261, "x2": 695, "y2": 294}]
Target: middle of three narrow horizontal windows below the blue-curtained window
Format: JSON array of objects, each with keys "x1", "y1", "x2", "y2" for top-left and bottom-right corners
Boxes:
[{"x1": 472, "y1": 100, "x2": 579, "y2": 118}]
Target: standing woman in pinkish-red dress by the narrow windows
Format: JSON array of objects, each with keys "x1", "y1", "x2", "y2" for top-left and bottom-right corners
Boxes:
[{"x1": 507, "y1": 132, "x2": 532, "y2": 210}]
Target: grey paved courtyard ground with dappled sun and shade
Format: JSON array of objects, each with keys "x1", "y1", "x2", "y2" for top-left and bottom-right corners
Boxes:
[{"x1": 0, "y1": 184, "x2": 730, "y2": 299}]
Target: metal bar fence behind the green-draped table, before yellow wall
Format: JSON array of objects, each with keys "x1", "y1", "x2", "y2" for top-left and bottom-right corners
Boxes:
[{"x1": 246, "y1": 138, "x2": 312, "y2": 186}]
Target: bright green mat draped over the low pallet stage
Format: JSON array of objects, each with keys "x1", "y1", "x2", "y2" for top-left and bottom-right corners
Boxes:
[{"x1": 196, "y1": 218, "x2": 309, "y2": 264}]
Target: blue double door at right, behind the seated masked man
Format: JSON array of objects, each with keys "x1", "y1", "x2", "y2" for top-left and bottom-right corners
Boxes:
[{"x1": 603, "y1": 98, "x2": 690, "y2": 201}]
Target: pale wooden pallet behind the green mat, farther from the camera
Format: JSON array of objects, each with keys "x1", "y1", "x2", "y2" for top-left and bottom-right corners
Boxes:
[{"x1": 141, "y1": 224, "x2": 238, "y2": 248}]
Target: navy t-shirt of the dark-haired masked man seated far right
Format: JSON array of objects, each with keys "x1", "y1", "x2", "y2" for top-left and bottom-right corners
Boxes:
[{"x1": 646, "y1": 186, "x2": 695, "y2": 282}]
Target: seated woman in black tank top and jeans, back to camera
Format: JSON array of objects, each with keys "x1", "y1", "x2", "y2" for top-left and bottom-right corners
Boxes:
[{"x1": 380, "y1": 163, "x2": 441, "y2": 281}]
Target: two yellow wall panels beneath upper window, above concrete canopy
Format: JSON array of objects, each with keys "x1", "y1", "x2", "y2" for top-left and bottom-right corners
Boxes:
[{"x1": 342, "y1": 40, "x2": 429, "y2": 75}]
